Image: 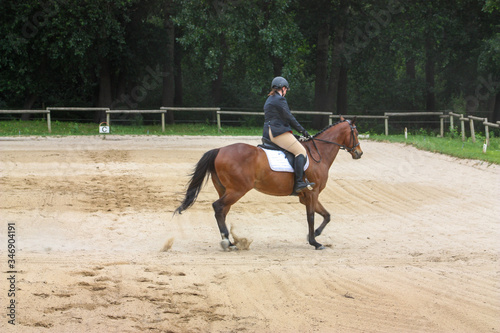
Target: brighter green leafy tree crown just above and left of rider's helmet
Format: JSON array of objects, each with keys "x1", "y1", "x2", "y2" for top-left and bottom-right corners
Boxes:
[{"x1": 174, "y1": 0, "x2": 301, "y2": 106}]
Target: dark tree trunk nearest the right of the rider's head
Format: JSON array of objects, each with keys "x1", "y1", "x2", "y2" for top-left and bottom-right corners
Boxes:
[{"x1": 312, "y1": 23, "x2": 330, "y2": 129}]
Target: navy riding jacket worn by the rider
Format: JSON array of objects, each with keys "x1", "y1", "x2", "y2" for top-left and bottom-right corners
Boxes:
[{"x1": 262, "y1": 93, "x2": 304, "y2": 139}]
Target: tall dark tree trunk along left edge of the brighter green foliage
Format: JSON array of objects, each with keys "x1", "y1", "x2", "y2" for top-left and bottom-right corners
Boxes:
[{"x1": 162, "y1": 2, "x2": 175, "y2": 124}]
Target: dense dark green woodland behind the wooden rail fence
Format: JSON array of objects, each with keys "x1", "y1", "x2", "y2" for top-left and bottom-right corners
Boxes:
[{"x1": 0, "y1": 0, "x2": 500, "y2": 128}]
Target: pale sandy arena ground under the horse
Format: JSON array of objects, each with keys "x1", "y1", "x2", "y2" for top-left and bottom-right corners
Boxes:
[{"x1": 0, "y1": 136, "x2": 500, "y2": 332}]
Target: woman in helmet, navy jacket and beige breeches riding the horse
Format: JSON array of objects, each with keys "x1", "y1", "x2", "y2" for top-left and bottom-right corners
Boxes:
[{"x1": 263, "y1": 76, "x2": 315, "y2": 193}]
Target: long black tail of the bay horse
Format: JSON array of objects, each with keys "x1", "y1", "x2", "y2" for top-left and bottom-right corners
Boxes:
[{"x1": 174, "y1": 149, "x2": 219, "y2": 215}]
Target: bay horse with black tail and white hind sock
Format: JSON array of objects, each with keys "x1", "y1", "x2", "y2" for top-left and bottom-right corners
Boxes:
[{"x1": 174, "y1": 116, "x2": 363, "y2": 250}]
